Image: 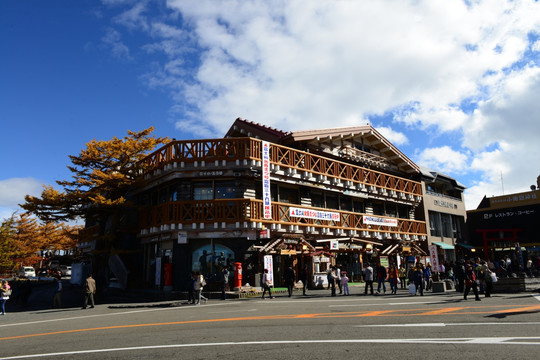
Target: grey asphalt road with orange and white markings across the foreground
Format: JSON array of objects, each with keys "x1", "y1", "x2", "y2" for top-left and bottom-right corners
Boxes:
[{"x1": 0, "y1": 290, "x2": 540, "y2": 360}]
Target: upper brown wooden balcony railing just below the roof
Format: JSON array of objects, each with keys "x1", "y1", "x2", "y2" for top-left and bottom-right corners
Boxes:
[{"x1": 143, "y1": 138, "x2": 422, "y2": 197}]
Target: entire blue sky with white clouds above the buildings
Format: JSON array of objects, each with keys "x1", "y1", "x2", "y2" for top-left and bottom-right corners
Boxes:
[{"x1": 0, "y1": 0, "x2": 540, "y2": 219}]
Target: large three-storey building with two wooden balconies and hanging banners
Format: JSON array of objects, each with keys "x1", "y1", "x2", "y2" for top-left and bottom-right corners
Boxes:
[{"x1": 129, "y1": 119, "x2": 427, "y2": 289}]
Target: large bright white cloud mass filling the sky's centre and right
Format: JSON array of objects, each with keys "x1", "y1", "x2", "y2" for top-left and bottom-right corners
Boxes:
[{"x1": 106, "y1": 0, "x2": 540, "y2": 208}]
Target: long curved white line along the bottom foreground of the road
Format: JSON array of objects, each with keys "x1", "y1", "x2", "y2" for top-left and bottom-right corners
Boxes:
[{"x1": 0, "y1": 336, "x2": 540, "y2": 360}]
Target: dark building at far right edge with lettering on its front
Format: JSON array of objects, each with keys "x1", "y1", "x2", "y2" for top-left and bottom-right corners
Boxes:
[{"x1": 467, "y1": 177, "x2": 540, "y2": 270}]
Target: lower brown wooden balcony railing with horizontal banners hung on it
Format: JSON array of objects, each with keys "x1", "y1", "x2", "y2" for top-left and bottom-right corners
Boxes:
[{"x1": 139, "y1": 199, "x2": 426, "y2": 236}]
